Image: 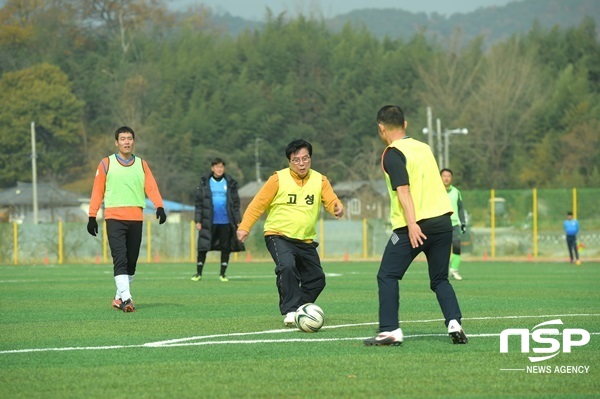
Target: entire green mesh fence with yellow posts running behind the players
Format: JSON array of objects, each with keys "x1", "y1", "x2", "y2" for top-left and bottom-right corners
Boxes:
[{"x1": 0, "y1": 189, "x2": 600, "y2": 264}]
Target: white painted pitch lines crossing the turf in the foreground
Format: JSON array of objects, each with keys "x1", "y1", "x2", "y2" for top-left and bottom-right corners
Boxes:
[{"x1": 0, "y1": 314, "x2": 600, "y2": 355}]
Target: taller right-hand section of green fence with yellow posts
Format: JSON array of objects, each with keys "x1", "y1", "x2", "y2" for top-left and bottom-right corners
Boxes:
[{"x1": 462, "y1": 189, "x2": 600, "y2": 260}]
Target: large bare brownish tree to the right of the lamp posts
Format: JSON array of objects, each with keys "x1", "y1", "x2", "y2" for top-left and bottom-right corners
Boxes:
[{"x1": 463, "y1": 39, "x2": 541, "y2": 187}]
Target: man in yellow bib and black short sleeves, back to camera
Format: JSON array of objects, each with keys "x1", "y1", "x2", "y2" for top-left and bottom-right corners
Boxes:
[{"x1": 364, "y1": 105, "x2": 468, "y2": 346}]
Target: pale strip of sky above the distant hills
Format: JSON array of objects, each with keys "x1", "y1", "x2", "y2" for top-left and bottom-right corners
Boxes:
[{"x1": 170, "y1": 0, "x2": 522, "y2": 21}]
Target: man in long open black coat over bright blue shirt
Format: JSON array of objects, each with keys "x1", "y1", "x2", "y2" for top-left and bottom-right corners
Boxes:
[{"x1": 192, "y1": 158, "x2": 244, "y2": 282}]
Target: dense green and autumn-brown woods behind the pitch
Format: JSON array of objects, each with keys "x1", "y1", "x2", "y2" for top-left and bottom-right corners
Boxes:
[{"x1": 0, "y1": 0, "x2": 600, "y2": 201}]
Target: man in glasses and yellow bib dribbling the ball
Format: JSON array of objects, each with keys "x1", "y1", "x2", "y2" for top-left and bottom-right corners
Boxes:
[{"x1": 237, "y1": 140, "x2": 344, "y2": 327}]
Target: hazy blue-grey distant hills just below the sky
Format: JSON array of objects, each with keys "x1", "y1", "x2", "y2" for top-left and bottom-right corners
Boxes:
[{"x1": 196, "y1": 0, "x2": 600, "y2": 46}]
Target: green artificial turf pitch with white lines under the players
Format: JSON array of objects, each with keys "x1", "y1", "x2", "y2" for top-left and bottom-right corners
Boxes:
[{"x1": 0, "y1": 262, "x2": 600, "y2": 399}]
